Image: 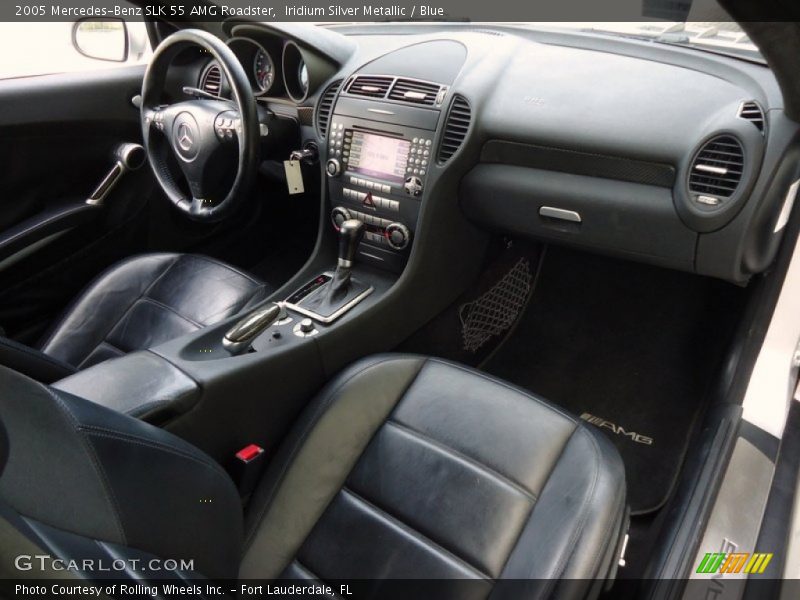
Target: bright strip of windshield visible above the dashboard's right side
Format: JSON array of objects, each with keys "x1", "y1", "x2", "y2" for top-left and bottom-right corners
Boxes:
[{"x1": 527, "y1": 21, "x2": 764, "y2": 62}]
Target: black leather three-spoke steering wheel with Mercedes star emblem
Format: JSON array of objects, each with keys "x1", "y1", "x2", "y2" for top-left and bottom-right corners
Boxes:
[{"x1": 141, "y1": 29, "x2": 259, "y2": 222}]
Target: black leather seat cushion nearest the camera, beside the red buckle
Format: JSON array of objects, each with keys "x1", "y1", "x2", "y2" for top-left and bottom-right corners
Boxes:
[{"x1": 240, "y1": 355, "x2": 626, "y2": 597}]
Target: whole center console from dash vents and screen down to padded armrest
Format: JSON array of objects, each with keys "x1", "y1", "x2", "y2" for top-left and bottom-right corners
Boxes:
[{"x1": 48, "y1": 40, "x2": 486, "y2": 464}]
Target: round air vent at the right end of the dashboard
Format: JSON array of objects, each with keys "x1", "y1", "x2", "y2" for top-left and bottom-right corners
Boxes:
[{"x1": 689, "y1": 135, "x2": 744, "y2": 200}]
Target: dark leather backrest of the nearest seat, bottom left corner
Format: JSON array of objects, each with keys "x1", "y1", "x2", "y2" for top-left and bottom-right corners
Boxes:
[{"x1": 0, "y1": 367, "x2": 242, "y2": 578}]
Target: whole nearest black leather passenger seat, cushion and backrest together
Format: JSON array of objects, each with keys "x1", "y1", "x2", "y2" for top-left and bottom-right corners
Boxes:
[{"x1": 0, "y1": 355, "x2": 627, "y2": 598}]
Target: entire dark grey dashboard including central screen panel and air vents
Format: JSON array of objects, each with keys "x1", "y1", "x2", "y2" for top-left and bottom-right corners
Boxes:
[{"x1": 183, "y1": 22, "x2": 800, "y2": 284}]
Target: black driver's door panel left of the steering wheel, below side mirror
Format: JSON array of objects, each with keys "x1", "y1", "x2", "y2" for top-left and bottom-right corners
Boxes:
[{"x1": 0, "y1": 66, "x2": 154, "y2": 343}]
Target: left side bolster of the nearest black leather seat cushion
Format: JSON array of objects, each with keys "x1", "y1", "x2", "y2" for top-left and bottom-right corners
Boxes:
[{"x1": 239, "y1": 355, "x2": 426, "y2": 578}]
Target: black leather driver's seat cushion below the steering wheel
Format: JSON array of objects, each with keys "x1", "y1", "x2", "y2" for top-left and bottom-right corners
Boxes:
[{"x1": 41, "y1": 254, "x2": 268, "y2": 369}]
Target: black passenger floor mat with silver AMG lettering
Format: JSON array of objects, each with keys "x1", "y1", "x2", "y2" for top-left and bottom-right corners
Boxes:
[{"x1": 485, "y1": 247, "x2": 744, "y2": 514}]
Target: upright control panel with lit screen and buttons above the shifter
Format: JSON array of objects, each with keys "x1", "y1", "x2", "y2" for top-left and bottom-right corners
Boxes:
[{"x1": 326, "y1": 92, "x2": 439, "y2": 272}]
